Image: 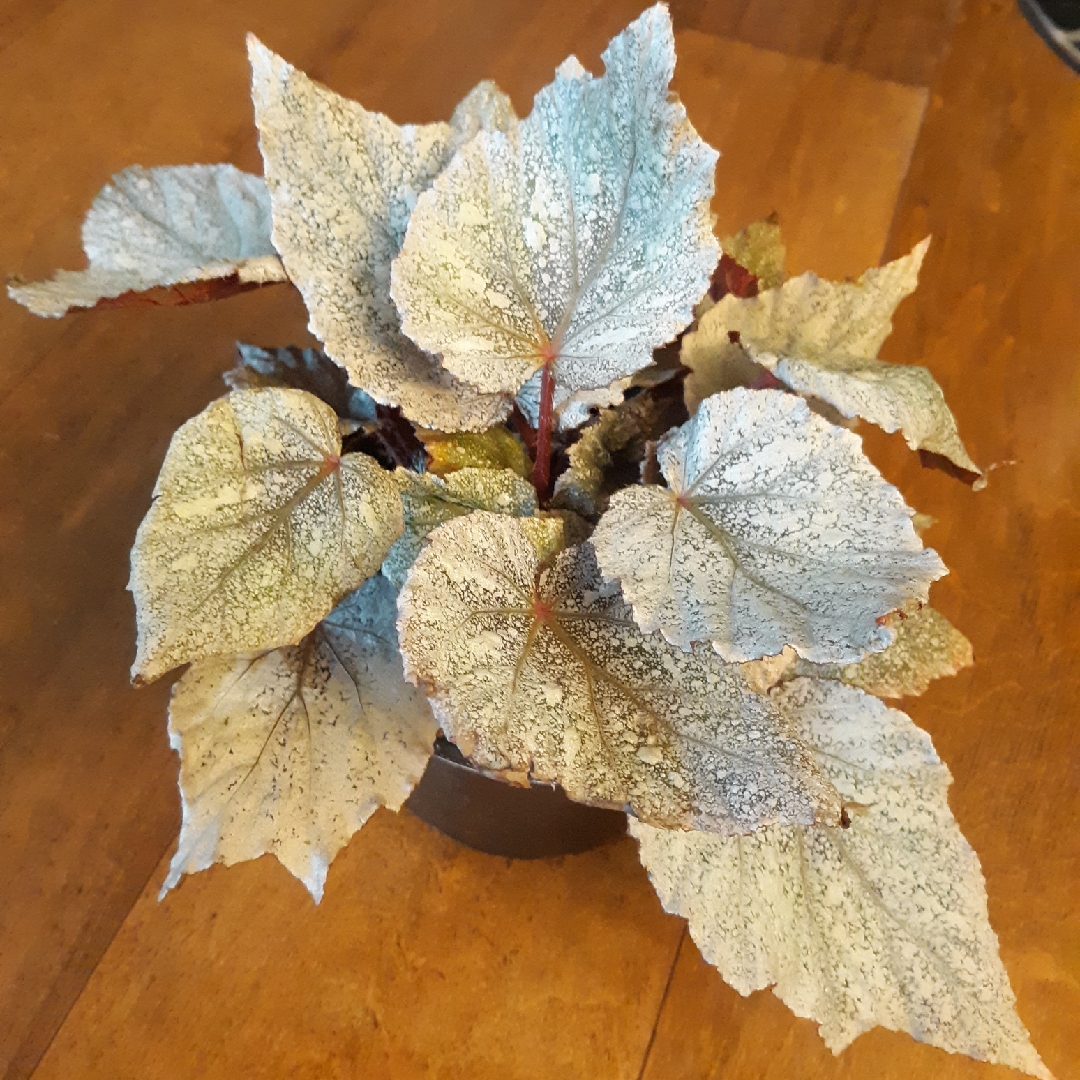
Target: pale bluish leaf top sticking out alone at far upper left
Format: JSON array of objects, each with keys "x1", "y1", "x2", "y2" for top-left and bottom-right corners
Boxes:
[{"x1": 8, "y1": 165, "x2": 286, "y2": 319}]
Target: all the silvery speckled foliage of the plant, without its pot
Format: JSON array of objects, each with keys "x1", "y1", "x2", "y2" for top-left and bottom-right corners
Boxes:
[{"x1": 11, "y1": 5, "x2": 1049, "y2": 1077}]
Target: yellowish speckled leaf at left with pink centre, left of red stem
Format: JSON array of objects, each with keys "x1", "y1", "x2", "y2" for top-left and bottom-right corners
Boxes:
[{"x1": 129, "y1": 389, "x2": 403, "y2": 680}]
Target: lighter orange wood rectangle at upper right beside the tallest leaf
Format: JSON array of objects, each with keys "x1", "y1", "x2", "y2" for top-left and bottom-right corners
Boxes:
[{"x1": 675, "y1": 30, "x2": 927, "y2": 278}]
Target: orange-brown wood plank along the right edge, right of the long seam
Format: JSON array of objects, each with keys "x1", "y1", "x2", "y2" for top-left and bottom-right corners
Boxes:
[{"x1": 644, "y1": 2, "x2": 1080, "y2": 1080}]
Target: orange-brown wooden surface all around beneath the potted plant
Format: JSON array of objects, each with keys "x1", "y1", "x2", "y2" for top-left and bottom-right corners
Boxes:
[{"x1": 0, "y1": 0, "x2": 1080, "y2": 1080}]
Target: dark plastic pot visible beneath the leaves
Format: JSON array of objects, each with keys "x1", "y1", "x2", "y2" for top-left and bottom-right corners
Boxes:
[{"x1": 405, "y1": 739, "x2": 626, "y2": 859}]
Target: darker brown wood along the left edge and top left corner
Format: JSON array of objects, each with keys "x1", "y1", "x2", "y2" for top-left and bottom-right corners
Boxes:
[{"x1": 0, "y1": 0, "x2": 640, "y2": 1080}]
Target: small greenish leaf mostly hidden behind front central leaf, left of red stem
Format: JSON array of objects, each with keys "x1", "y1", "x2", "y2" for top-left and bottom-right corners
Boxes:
[{"x1": 382, "y1": 468, "x2": 537, "y2": 588}]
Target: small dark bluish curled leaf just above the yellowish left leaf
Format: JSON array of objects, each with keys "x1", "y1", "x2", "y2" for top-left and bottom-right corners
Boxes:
[{"x1": 222, "y1": 341, "x2": 376, "y2": 423}]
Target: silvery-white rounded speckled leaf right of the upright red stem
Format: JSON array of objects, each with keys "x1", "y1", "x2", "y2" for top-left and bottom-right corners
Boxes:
[{"x1": 593, "y1": 390, "x2": 946, "y2": 661}]
